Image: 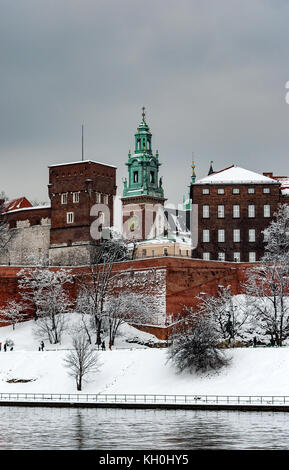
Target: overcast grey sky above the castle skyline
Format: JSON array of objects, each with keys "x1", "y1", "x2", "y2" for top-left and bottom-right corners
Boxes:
[{"x1": 0, "y1": 0, "x2": 289, "y2": 202}]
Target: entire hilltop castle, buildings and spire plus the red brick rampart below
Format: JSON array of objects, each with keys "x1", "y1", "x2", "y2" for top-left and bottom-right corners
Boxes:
[{"x1": 0, "y1": 109, "x2": 289, "y2": 339}]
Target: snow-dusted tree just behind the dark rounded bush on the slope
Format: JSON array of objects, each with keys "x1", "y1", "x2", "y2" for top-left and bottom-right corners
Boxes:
[{"x1": 199, "y1": 285, "x2": 248, "y2": 344}]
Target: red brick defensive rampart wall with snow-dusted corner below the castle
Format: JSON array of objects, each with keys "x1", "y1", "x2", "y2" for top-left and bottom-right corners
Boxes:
[{"x1": 0, "y1": 256, "x2": 252, "y2": 339}]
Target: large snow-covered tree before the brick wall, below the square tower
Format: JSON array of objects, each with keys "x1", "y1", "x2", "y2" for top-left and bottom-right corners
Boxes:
[{"x1": 19, "y1": 267, "x2": 73, "y2": 344}]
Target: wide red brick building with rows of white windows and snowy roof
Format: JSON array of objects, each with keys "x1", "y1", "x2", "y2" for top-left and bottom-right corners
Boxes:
[{"x1": 191, "y1": 165, "x2": 282, "y2": 262}]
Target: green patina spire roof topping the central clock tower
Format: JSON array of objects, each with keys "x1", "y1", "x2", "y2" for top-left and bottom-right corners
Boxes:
[{"x1": 123, "y1": 107, "x2": 164, "y2": 198}]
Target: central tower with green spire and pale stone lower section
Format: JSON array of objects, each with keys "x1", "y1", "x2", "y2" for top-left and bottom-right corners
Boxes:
[{"x1": 122, "y1": 107, "x2": 166, "y2": 240}]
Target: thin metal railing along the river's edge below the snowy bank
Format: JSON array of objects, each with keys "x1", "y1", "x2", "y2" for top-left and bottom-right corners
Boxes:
[{"x1": 0, "y1": 393, "x2": 289, "y2": 407}]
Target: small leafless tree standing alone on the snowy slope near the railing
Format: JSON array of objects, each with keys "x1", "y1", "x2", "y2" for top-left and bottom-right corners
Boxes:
[{"x1": 64, "y1": 333, "x2": 99, "y2": 391}]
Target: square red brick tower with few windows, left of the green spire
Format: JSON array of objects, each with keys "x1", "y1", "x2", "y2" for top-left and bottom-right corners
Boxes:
[{"x1": 48, "y1": 160, "x2": 116, "y2": 266}]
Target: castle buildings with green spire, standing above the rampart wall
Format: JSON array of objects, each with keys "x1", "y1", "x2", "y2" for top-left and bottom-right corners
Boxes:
[{"x1": 0, "y1": 108, "x2": 289, "y2": 266}]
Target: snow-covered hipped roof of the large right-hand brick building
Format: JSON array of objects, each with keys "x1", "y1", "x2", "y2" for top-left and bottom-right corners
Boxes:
[{"x1": 195, "y1": 165, "x2": 279, "y2": 184}]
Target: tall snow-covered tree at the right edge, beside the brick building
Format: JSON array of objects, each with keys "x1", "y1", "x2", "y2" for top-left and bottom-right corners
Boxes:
[{"x1": 244, "y1": 204, "x2": 289, "y2": 346}]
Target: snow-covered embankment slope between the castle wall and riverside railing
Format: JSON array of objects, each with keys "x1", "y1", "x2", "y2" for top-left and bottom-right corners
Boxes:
[{"x1": 0, "y1": 321, "x2": 289, "y2": 395}]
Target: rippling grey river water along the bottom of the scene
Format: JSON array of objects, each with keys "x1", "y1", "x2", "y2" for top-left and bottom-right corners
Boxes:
[{"x1": 0, "y1": 407, "x2": 289, "y2": 450}]
